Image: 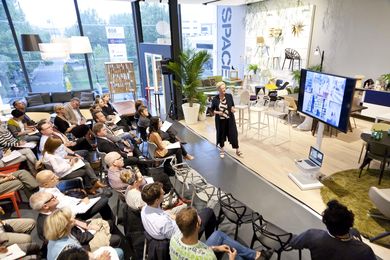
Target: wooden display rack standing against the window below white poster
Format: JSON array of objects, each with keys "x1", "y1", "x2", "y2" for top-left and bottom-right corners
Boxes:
[{"x1": 104, "y1": 61, "x2": 137, "y2": 100}]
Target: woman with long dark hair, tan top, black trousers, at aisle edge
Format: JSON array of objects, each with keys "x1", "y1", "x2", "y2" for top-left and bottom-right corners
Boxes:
[{"x1": 149, "y1": 117, "x2": 194, "y2": 170}]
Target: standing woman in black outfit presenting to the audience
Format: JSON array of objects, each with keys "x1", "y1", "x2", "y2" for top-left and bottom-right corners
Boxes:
[{"x1": 211, "y1": 82, "x2": 242, "y2": 158}]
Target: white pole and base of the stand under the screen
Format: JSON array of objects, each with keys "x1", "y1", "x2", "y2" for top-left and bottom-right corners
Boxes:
[{"x1": 288, "y1": 122, "x2": 324, "y2": 190}]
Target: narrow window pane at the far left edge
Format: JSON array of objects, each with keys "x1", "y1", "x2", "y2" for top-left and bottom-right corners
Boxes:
[{"x1": 0, "y1": 2, "x2": 28, "y2": 106}]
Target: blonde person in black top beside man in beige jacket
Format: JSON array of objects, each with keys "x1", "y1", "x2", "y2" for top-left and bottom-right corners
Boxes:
[{"x1": 54, "y1": 104, "x2": 90, "y2": 138}]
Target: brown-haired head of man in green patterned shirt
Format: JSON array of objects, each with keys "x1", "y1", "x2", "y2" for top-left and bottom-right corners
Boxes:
[{"x1": 176, "y1": 207, "x2": 200, "y2": 237}]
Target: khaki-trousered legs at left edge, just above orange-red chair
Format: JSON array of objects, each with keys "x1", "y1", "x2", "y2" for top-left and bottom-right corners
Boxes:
[{"x1": 0, "y1": 170, "x2": 38, "y2": 195}]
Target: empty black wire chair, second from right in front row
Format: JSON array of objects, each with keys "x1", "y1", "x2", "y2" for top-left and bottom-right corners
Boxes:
[{"x1": 216, "y1": 188, "x2": 253, "y2": 240}]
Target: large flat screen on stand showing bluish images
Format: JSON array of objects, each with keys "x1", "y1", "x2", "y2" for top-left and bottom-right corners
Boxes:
[{"x1": 298, "y1": 69, "x2": 356, "y2": 133}]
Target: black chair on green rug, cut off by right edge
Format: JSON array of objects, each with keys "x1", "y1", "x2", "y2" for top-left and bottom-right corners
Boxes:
[{"x1": 359, "y1": 140, "x2": 390, "y2": 185}]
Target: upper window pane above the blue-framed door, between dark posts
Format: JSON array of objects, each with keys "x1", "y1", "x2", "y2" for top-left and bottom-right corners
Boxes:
[{"x1": 140, "y1": 2, "x2": 171, "y2": 44}]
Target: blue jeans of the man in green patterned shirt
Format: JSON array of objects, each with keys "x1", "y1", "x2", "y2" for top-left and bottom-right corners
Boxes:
[{"x1": 206, "y1": 231, "x2": 256, "y2": 259}]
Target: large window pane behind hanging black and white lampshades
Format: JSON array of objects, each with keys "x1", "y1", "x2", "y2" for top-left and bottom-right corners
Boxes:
[{"x1": 13, "y1": 0, "x2": 90, "y2": 92}]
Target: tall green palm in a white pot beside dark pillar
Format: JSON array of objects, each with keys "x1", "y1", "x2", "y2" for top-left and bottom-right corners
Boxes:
[{"x1": 167, "y1": 50, "x2": 210, "y2": 124}]
